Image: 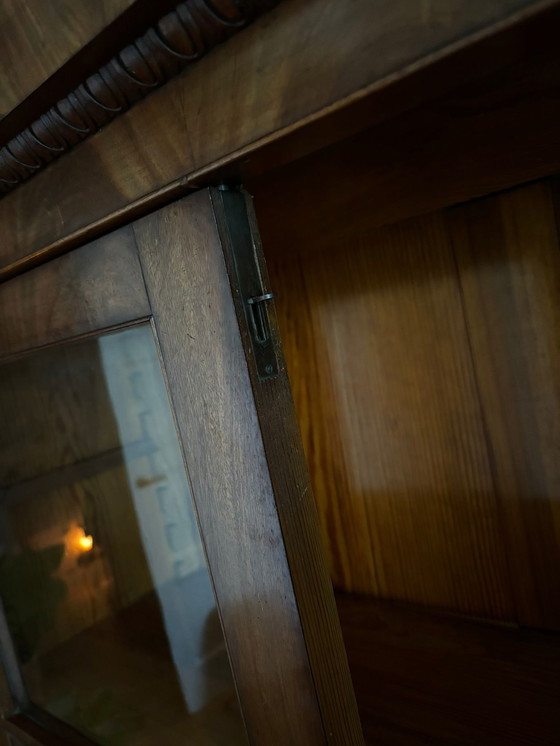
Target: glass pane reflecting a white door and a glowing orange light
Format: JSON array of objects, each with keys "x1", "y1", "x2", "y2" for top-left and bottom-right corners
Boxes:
[{"x1": 0, "y1": 324, "x2": 246, "y2": 746}]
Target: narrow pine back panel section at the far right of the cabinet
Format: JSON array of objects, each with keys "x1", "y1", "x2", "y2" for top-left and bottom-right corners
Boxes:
[{"x1": 450, "y1": 182, "x2": 560, "y2": 629}]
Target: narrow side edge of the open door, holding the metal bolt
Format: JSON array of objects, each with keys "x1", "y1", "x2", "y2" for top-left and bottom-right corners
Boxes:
[{"x1": 212, "y1": 189, "x2": 363, "y2": 744}]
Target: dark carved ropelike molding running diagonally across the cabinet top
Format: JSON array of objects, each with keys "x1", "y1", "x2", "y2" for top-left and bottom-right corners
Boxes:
[{"x1": 0, "y1": 0, "x2": 279, "y2": 194}]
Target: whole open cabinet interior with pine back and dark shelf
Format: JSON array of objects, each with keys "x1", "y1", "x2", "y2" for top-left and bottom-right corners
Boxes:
[{"x1": 248, "y1": 49, "x2": 560, "y2": 744}]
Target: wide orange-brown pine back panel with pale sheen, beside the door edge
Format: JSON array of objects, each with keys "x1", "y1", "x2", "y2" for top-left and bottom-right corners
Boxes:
[{"x1": 263, "y1": 209, "x2": 514, "y2": 619}]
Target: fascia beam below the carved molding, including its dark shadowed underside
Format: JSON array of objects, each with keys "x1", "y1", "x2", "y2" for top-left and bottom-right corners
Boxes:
[{"x1": 0, "y1": 0, "x2": 560, "y2": 277}]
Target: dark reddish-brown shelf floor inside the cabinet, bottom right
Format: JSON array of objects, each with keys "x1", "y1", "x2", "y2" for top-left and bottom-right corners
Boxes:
[{"x1": 337, "y1": 594, "x2": 560, "y2": 746}]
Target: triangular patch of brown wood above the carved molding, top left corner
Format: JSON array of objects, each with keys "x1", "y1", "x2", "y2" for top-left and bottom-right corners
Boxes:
[{"x1": 0, "y1": 0, "x2": 132, "y2": 117}]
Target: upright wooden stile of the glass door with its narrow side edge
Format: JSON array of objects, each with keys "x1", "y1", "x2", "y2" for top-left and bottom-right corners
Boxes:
[{"x1": 134, "y1": 191, "x2": 363, "y2": 746}]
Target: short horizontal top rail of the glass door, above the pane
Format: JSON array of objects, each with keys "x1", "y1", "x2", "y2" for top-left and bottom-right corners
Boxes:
[{"x1": 0, "y1": 228, "x2": 150, "y2": 358}]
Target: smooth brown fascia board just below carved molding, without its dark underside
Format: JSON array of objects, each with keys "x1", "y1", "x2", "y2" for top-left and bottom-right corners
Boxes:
[{"x1": 0, "y1": 0, "x2": 554, "y2": 274}]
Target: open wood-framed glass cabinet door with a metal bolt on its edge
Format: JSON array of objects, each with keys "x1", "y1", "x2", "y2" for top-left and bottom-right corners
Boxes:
[{"x1": 0, "y1": 190, "x2": 363, "y2": 746}]
